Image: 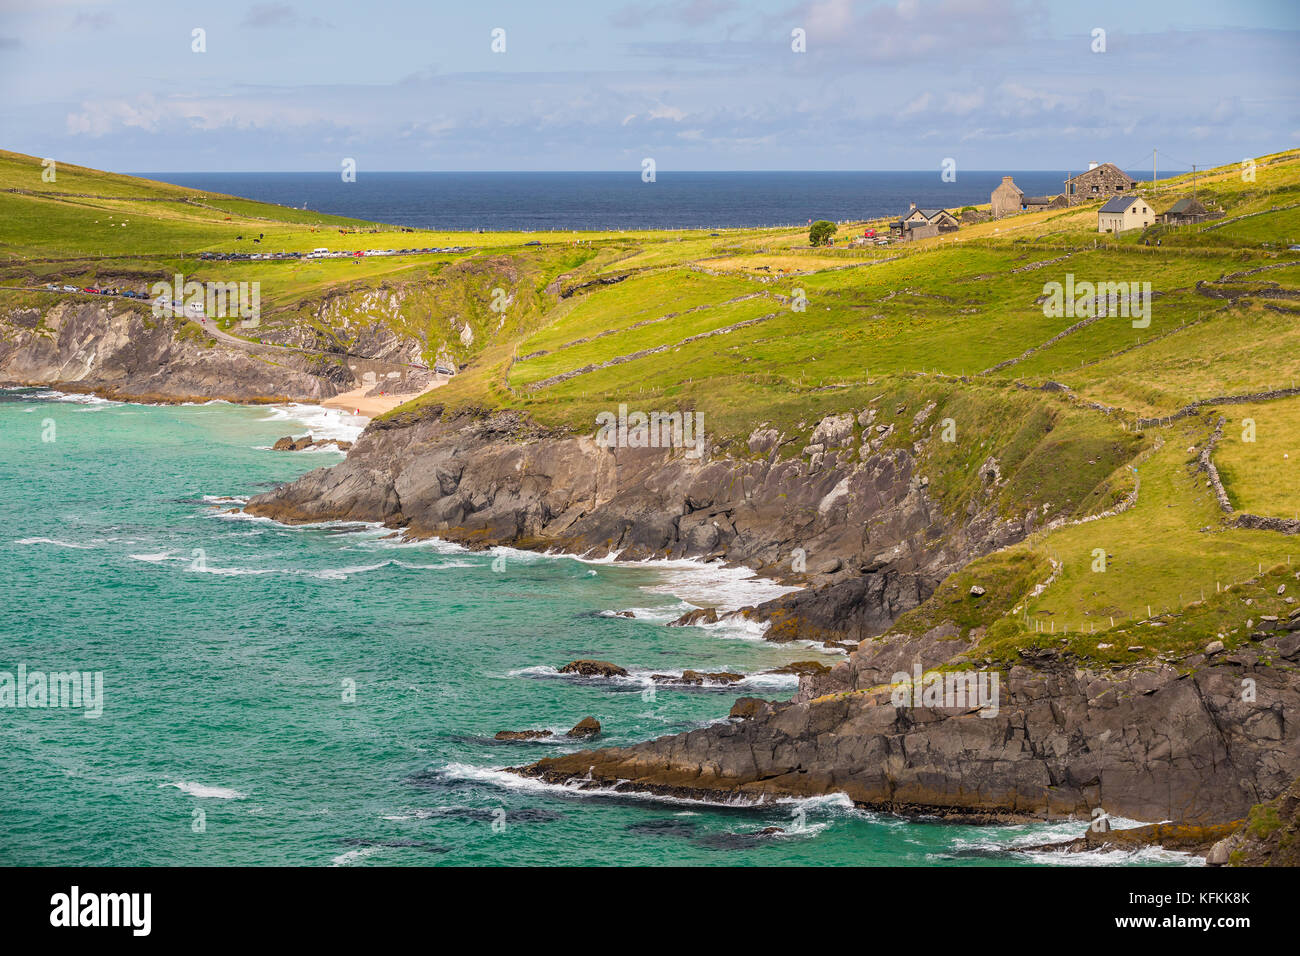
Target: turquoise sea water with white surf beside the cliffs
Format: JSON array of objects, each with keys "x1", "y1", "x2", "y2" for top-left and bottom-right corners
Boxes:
[{"x1": 0, "y1": 390, "x2": 1187, "y2": 866}]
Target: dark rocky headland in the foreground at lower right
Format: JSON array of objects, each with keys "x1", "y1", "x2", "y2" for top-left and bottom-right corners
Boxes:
[{"x1": 517, "y1": 633, "x2": 1300, "y2": 825}]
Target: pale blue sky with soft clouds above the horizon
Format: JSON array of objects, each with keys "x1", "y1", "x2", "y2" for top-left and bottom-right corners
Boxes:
[{"x1": 0, "y1": 0, "x2": 1300, "y2": 174}]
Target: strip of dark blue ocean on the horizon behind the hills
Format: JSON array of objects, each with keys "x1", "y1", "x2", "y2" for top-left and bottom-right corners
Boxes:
[{"x1": 135, "y1": 169, "x2": 1097, "y2": 230}]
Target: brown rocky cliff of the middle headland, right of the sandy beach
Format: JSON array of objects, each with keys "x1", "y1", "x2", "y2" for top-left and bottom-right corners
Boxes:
[{"x1": 248, "y1": 405, "x2": 1026, "y2": 621}]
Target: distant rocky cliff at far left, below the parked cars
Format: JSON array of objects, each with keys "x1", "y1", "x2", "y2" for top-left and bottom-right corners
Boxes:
[{"x1": 0, "y1": 302, "x2": 338, "y2": 402}]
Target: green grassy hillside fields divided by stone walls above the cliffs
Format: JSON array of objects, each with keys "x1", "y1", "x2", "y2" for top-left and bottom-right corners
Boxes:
[{"x1": 0, "y1": 151, "x2": 1300, "y2": 662}]
